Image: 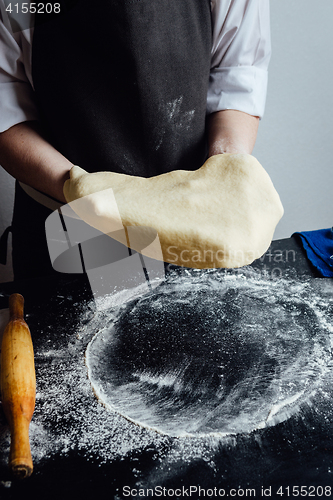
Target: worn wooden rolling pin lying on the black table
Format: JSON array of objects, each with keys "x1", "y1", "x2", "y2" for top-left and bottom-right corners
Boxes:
[{"x1": 0, "y1": 293, "x2": 36, "y2": 479}]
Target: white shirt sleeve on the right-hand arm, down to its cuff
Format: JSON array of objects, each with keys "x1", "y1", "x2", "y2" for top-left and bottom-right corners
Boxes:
[{"x1": 207, "y1": 0, "x2": 271, "y2": 118}]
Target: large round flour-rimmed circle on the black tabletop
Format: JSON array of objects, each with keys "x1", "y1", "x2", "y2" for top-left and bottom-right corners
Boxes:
[{"x1": 86, "y1": 275, "x2": 330, "y2": 436}]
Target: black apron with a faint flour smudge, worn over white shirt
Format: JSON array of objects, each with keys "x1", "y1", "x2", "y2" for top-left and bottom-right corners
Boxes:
[{"x1": 12, "y1": 0, "x2": 211, "y2": 278}]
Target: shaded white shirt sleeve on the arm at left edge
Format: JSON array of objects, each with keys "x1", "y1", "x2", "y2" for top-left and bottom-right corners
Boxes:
[{"x1": 0, "y1": 0, "x2": 38, "y2": 132}]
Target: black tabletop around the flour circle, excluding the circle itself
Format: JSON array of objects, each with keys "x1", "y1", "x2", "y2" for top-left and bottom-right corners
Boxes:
[{"x1": 0, "y1": 238, "x2": 333, "y2": 499}]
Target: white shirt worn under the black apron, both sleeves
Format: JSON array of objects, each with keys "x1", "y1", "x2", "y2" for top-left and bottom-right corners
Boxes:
[{"x1": 0, "y1": 0, "x2": 271, "y2": 132}]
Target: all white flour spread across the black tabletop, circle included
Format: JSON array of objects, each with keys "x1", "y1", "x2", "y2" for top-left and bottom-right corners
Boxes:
[{"x1": 0, "y1": 270, "x2": 333, "y2": 469}]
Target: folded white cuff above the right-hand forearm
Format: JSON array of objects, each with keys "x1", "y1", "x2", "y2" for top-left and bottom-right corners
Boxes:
[{"x1": 207, "y1": 66, "x2": 268, "y2": 118}]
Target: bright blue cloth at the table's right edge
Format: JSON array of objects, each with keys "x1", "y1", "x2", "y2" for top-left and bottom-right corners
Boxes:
[{"x1": 292, "y1": 228, "x2": 333, "y2": 278}]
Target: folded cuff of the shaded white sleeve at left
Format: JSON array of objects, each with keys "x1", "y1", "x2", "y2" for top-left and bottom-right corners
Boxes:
[{"x1": 0, "y1": 82, "x2": 39, "y2": 133}]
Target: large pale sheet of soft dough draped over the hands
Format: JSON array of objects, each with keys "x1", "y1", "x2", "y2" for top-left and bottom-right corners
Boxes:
[{"x1": 64, "y1": 154, "x2": 283, "y2": 269}]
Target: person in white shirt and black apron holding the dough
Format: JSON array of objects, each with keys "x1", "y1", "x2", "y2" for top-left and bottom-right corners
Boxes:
[{"x1": 0, "y1": 0, "x2": 271, "y2": 279}]
